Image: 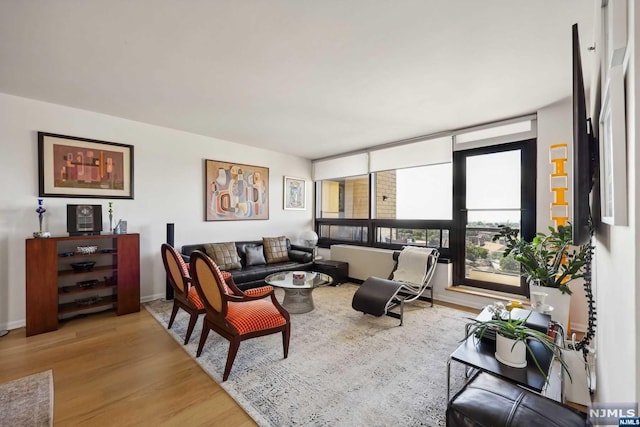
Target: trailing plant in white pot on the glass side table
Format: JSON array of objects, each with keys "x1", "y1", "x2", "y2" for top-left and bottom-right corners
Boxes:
[{"x1": 465, "y1": 304, "x2": 571, "y2": 379}]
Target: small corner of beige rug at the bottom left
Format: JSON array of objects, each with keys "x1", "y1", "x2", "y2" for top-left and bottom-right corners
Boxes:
[{"x1": 0, "y1": 370, "x2": 53, "y2": 427}]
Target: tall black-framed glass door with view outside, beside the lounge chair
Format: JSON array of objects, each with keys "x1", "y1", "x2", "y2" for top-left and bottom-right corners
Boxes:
[{"x1": 453, "y1": 140, "x2": 536, "y2": 295}]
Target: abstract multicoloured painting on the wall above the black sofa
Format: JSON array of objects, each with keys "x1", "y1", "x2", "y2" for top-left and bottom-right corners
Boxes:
[{"x1": 205, "y1": 160, "x2": 269, "y2": 221}]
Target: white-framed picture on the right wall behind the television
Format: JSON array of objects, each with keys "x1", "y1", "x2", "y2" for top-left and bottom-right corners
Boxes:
[{"x1": 600, "y1": 65, "x2": 627, "y2": 225}]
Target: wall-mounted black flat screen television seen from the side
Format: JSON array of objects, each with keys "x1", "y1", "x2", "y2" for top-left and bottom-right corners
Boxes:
[{"x1": 572, "y1": 24, "x2": 598, "y2": 245}]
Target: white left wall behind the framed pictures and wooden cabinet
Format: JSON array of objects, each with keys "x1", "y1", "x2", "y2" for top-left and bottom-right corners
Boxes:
[{"x1": 0, "y1": 94, "x2": 313, "y2": 329}]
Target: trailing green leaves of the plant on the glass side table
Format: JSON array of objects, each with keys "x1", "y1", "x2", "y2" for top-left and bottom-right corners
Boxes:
[{"x1": 465, "y1": 310, "x2": 573, "y2": 381}]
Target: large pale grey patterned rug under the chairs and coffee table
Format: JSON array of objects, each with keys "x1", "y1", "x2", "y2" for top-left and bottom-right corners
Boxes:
[{"x1": 145, "y1": 284, "x2": 469, "y2": 426}]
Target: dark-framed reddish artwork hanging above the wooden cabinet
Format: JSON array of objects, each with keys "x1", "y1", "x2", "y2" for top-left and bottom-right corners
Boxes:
[{"x1": 38, "y1": 132, "x2": 133, "y2": 199}]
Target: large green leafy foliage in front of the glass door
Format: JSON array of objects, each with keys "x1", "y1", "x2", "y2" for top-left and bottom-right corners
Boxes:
[{"x1": 493, "y1": 223, "x2": 590, "y2": 294}]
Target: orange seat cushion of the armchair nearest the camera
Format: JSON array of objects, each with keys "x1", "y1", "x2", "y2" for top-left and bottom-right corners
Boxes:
[{"x1": 227, "y1": 300, "x2": 287, "y2": 335}]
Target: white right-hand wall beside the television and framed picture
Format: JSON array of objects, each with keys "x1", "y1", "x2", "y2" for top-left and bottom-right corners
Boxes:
[{"x1": 594, "y1": 0, "x2": 640, "y2": 402}]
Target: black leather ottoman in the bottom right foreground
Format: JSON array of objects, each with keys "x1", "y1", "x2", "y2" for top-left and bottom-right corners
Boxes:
[{"x1": 447, "y1": 373, "x2": 590, "y2": 427}]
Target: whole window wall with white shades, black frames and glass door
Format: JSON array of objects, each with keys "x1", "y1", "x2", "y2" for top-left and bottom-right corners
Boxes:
[{"x1": 313, "y1": 115, "x2": 537, "y2": 288}]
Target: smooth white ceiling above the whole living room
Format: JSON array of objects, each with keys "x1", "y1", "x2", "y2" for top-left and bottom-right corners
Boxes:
[{"x1": 0, "y1": 0, "x2": 594, "y2": 159}]
